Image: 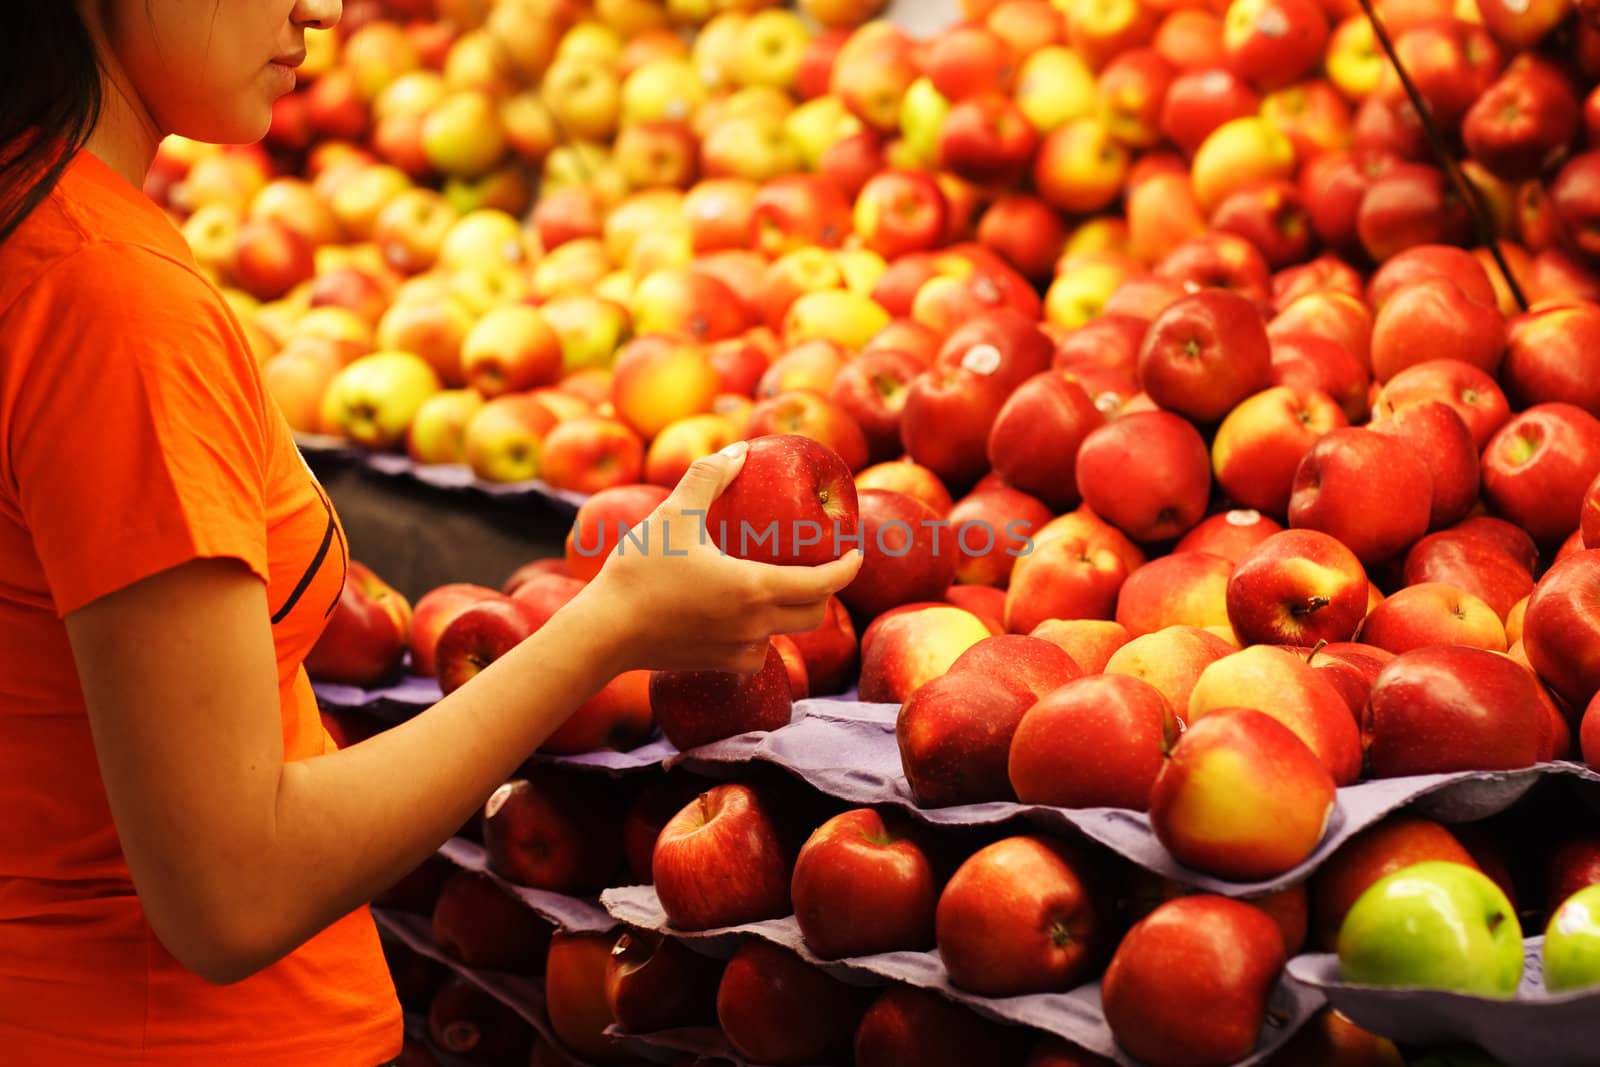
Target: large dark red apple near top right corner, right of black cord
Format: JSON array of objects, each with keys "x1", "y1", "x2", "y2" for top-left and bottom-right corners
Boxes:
[{"x1": 1461, "y1": 54, "x2": 1581, "y2": 181}]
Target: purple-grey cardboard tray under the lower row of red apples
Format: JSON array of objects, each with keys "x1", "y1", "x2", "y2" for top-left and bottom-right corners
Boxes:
[{"x1": 600, "y1": 886, "x2": 1323, "y2": 1067}]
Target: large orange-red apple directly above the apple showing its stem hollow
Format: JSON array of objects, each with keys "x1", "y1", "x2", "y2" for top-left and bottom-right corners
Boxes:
[{"x1": 1288, "y1": 427, "x2": 1434, "y2": 565}]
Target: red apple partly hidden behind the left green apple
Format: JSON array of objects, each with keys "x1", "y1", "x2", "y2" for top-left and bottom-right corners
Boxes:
[{"x1": 1310, "y1": 813, "x2": 1477, "y2": 952}]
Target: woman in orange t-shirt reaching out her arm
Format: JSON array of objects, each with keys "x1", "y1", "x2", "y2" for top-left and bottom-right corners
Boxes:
[{"x1": 0, "y1": 0, "x2": 859, "y2": 1067}]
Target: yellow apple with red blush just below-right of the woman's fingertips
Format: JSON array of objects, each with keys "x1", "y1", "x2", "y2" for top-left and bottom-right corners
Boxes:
[{"x1": 858, "y1": 601, "x2": 992, "y2": 704}]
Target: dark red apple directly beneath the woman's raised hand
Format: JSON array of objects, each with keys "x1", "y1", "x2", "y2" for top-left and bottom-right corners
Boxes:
[{"x1": 650, "y1": 641, "x2": 794, "y2": 752}]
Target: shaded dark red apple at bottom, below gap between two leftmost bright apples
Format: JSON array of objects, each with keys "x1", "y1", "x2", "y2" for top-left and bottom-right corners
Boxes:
[{"x1": 717, "y1": 937, "x2": 874, "y2": 1064}]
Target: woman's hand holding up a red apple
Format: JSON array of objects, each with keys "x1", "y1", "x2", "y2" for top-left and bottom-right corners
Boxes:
[{"x1": 579, "y1": 442, "x2": 861, "y2": 673}]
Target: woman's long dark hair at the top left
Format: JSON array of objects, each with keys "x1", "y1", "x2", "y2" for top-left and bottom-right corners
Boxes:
[{"x1": 0, "y1": 0, "x2": 101, "y2": 242}]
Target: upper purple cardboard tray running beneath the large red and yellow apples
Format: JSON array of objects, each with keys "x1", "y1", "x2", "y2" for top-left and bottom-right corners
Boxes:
[{"x1": 672, "y1": 701, "x2": 1600, "y2": 896}]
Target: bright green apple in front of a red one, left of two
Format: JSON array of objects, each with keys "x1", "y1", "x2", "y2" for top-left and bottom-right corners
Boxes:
[{"x1": 1338, "y1": 861, "x2": 1523, "y2": 997}]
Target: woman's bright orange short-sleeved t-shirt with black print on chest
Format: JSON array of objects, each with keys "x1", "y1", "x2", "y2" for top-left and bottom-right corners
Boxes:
[{"x1": 0, "y1": 152, "x2": 402, "y2": 1067}]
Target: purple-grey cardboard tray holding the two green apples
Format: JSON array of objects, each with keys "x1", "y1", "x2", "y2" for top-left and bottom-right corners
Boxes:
[{"x1": 1290, "y1": 937, "x2": 1600, "y2": 1067}]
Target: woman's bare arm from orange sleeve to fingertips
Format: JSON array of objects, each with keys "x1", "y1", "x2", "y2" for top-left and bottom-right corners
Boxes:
[{"x1": 67, "y1": 447, "x2": 859, "y2": 982}]
